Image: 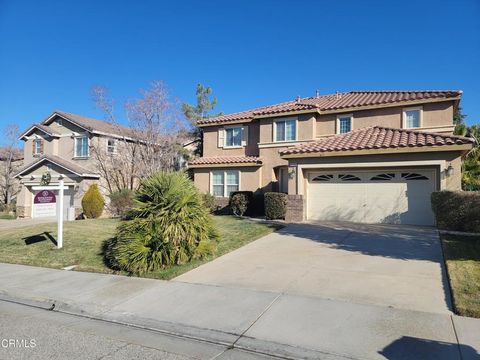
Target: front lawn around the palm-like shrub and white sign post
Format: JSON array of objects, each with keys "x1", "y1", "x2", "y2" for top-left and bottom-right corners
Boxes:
[{"x1": 0, "y1": 216, "x2": 276, "y2": 279}]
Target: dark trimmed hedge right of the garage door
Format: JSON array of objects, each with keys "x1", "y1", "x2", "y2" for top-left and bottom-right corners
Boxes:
[{"x1": 432, "y1": 191, "x2": 480, "y2": 232}]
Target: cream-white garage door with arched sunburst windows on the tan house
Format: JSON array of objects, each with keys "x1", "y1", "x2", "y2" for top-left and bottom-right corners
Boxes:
[{"x1": 307, "y1": 169, "x2": 436, "y2": 225}]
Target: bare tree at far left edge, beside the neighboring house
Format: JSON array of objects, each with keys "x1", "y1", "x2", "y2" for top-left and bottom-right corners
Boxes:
[{"x1": 0, "y1": 124, "x2": 23, "y2": 205}]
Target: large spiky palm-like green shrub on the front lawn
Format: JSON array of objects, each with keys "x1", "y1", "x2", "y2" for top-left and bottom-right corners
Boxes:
[{"x1": 107, "y1": 172, "x2": 218, "y2": 274}]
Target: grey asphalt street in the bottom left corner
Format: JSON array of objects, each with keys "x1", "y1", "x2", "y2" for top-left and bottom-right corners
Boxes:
[{"x1": 0, "y1": 301, "x2": 274, "y2": 360}]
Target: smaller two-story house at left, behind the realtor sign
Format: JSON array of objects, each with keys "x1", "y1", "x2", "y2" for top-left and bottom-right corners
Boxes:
[{"x1": 15, "y1": 111, "x2": 138, "y2": 218}]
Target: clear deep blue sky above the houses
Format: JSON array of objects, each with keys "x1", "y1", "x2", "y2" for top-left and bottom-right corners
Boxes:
[{"x1": 0, "y1": 0, "x2": 480, "y2": 145}]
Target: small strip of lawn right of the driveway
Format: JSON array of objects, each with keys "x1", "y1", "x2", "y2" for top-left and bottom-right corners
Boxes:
[{"x1": 441, "y1": 234, "x2": 480, "y2": 318}]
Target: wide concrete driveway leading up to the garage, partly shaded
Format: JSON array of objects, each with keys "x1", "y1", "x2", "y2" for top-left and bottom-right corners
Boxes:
[{"x1": 175, "y1": 223, "x2": 451, "y2": 313}]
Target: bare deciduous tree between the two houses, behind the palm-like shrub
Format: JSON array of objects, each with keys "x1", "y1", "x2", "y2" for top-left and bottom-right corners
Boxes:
[{"x1": 91, "y1": 81, "x2": 187, "y2": 193}]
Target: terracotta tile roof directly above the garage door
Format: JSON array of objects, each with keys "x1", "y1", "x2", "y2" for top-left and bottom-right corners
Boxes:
[{"x1": 280, "y1": 126, "x2": 475, "y2": 155}]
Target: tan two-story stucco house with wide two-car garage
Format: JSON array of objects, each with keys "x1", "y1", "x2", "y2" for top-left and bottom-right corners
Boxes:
[{"x1": 189, "y1": 91, "x2": 474, "y2": 225}]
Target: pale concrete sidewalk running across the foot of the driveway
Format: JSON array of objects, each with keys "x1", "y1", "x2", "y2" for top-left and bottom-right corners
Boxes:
[{"x1": 0, "y1": 264, "x2": 480, "y2": 360}]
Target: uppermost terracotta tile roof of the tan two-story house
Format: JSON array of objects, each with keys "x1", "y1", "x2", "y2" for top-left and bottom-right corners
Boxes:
[{"x1": 198, "y1": 90, "x2": 462, "y2": 125}]
